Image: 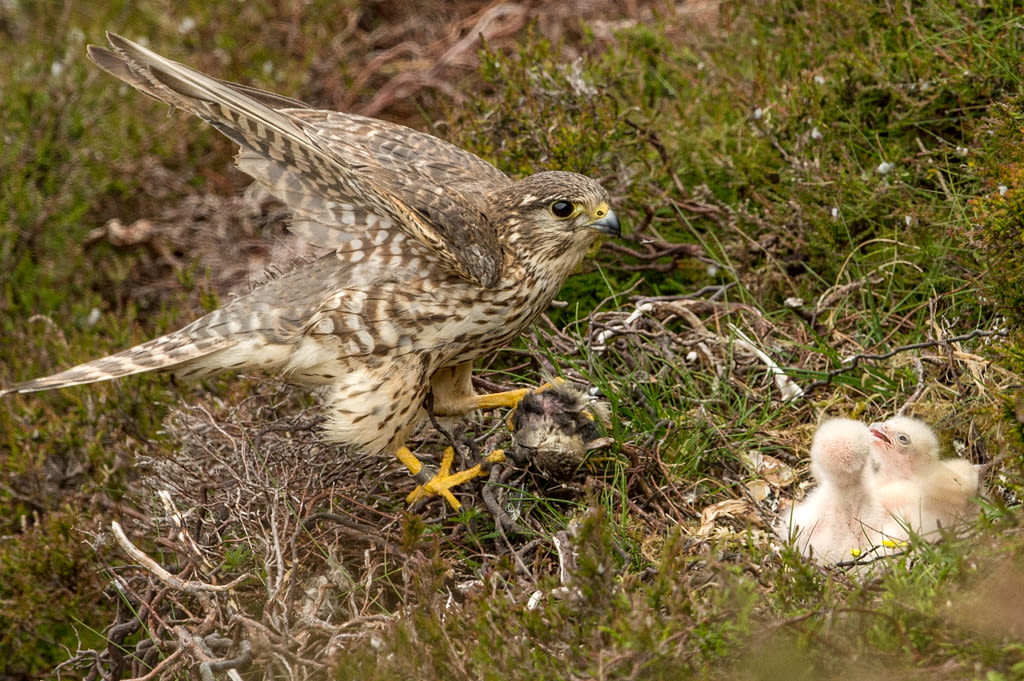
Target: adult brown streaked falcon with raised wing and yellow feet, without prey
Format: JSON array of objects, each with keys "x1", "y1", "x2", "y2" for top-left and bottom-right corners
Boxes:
[{"x1": 0, "y1": 34, "x2": 620, "y2": 508}]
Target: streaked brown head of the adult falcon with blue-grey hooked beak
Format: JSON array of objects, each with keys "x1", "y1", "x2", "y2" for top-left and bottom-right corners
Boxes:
[{"x1": 489, "y1": 171, "x2": 622, "y2": 280}]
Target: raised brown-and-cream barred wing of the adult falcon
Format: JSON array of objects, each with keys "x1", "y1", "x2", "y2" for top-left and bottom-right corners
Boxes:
[{"x1": 89, "y1": 34, "x2": 511, "y2": 287}]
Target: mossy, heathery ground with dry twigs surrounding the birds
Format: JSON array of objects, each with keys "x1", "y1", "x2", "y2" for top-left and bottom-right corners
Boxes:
[{"x1": 6, "y1": 0, "x2": 1024, "y2": 681}]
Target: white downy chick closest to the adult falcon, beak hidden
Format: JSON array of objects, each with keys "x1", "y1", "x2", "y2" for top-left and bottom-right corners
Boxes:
[{"x1": 776, "y1": 419, "x2": 886, "y2": 563}]
